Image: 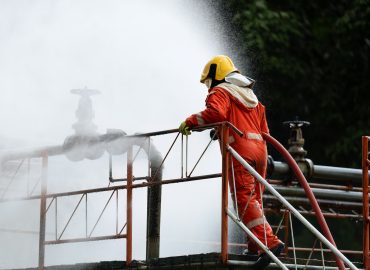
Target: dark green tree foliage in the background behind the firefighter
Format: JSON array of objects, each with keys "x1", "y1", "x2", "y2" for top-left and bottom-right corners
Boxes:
[{"x1": 220, "y1": 0, "x2": 370, "y2": 167}]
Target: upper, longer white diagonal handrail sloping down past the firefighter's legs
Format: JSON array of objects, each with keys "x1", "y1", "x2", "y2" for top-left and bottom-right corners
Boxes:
[{"x1": 227, "y1": 146, "x2": 359, "y2": 270}]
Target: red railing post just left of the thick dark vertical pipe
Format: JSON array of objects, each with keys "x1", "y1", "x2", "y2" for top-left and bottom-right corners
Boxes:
[{"x1": 126, "y1": 146, "x2": 133, "y2": 265}]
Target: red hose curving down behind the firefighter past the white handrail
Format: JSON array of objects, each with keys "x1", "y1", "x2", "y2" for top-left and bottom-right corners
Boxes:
[{"x1": 262, "y1": 133, "x2": 345, "y2": 270}]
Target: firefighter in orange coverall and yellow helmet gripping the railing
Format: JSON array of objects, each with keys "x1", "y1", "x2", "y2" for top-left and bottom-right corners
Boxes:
[{"x1": 179, "y1": 55, "x2": 284, "y2": 269}]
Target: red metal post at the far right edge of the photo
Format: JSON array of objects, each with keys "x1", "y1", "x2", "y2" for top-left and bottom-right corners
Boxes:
[{"x1": 362, "y1": 136, "x2": 370, "y2": 270}]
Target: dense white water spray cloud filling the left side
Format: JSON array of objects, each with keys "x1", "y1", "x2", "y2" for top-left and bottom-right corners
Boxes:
[{"x1": 0, "y1": 0, "x2": 237, "y2": 268}]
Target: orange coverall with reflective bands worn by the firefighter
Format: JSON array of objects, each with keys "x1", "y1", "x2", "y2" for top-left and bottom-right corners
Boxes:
[{"x1": 185, "y1": 86, "x2": 280, "y2": 252}]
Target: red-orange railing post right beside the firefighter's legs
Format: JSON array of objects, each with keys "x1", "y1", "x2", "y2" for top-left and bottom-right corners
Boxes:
[{"x1": 219, "y1": 124, "x2": 230, "y2": 264}]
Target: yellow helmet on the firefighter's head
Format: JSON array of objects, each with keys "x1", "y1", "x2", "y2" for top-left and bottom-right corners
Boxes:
[{"x1": 200, "y1": 55, "x2": 239, "y2": 83}]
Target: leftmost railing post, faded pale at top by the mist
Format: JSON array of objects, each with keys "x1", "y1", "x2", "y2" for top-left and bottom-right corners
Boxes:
[{"x1": 39, "y1": 152, "x2": 48, "y2": 270}]
